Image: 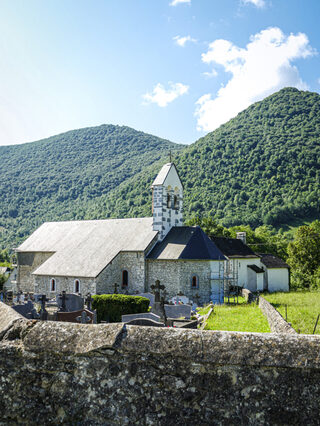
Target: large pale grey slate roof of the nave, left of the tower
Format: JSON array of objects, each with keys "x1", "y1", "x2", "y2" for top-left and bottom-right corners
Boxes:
[{"x1": 17, "y1": 217, "x2": 157, "y2": 278}]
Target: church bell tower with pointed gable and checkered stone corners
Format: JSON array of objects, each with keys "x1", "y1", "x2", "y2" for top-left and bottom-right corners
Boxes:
[{"x1": 151, "y1": 163, "x2": 183, "y2": 241}]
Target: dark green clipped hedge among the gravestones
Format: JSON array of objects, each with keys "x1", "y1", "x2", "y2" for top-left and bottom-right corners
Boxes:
[{"x1": 92, "y1": 294, "x2": 150, "y2": 322}]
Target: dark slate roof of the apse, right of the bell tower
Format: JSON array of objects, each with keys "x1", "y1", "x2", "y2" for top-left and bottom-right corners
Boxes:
[{"x1": 148, "y1": 226, "x2": 226, "y2": 260}]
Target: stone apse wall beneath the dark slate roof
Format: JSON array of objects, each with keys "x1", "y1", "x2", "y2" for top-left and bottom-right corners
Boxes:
[{"x1": 147, "y1": 259, "x2": 211, "y2": 303}]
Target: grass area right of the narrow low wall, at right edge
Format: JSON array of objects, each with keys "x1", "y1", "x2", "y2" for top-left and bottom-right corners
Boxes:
[{"x1": 263, "y1": 291, "x2": 320, "y2": 334}]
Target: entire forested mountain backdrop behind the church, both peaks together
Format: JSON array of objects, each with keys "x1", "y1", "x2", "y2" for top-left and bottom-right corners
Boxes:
[{"x1": 0, "y1": 88, "x2": 320, "y2": 248}]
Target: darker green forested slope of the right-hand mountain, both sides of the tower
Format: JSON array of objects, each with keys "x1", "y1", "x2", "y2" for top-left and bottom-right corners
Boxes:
[{"x1": 97, "y1": 88, "x2": 320, "y2": 227}]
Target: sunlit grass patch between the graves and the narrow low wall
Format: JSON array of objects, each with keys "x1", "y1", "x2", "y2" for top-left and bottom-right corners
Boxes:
[{"x1": 205, "y1": 298, "x2": 270, "y2": 333}]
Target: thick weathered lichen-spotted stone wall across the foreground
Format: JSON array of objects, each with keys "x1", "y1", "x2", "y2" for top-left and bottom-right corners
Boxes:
[{"x1": 0, "y1": 304, "x2": 320, "y2": 426}]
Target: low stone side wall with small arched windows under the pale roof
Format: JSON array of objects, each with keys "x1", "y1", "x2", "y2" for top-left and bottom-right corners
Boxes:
[{"x1": 34, "y1": 275, "x2": 96, "y2": 298}]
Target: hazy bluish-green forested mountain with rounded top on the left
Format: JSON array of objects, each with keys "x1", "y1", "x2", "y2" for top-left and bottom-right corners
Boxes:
[{"x1": 0, "y1": 125, "x2": 184, "y2": 248}]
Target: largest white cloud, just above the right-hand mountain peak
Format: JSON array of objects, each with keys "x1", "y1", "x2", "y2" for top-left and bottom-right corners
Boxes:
[{"x1": 195, "y1": 28, "x2": 316, "y2": 131}]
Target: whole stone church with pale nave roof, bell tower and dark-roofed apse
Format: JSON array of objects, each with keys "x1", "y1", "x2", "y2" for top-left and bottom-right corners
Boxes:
[{"x1": 16, "y1": 163, "x2": 226, "y2": 303}]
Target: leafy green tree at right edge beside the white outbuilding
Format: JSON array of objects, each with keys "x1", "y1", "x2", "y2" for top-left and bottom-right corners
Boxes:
[{"x1": 287, "y1": 220, "x2": 320, "y2": 289}]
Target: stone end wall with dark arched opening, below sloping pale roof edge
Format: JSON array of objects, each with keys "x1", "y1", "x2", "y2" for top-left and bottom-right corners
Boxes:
[{"x1": 96, "y1": 252, "x2": 145, "y2": 294}]
